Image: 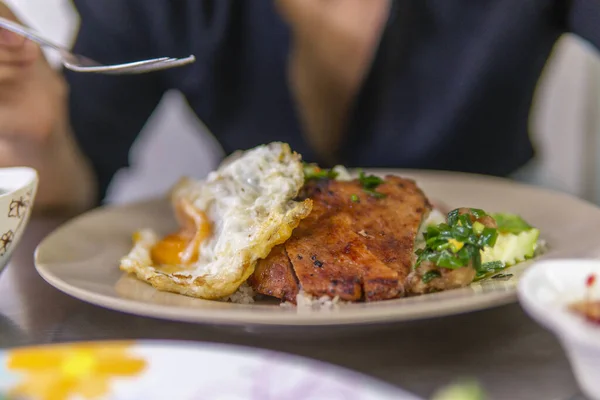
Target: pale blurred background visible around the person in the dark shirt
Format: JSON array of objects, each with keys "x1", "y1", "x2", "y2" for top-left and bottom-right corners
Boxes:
[{"x1": 6, "y1": 0, "x2": 600, "y2": 204}]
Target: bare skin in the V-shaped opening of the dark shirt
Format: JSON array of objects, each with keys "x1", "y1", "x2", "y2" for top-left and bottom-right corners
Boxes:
[{"x1": 276, "y1": 0, "x2": 390, "y2": 162}]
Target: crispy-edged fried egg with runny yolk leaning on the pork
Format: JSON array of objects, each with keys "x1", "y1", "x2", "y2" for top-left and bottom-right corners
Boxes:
[{"x1": 120, "y1": 143, "x2": 312, "y2": 299}]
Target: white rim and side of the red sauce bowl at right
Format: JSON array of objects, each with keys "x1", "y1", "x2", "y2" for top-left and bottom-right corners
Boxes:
[{"x1": 518, "y1": 259, "x2": 600, "y2": 400}]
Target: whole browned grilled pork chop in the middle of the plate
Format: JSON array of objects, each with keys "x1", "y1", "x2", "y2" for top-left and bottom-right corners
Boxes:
[{"x1": 249, "y1": 176, "x2": 431, "y2": 302}]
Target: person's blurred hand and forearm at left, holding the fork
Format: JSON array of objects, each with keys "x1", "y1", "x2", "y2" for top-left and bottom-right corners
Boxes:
[{"x1": 0, "y1": 1, "x2": 92, "y2": 212}]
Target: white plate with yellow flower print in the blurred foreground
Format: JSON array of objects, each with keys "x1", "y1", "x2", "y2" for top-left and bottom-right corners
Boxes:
[{"x1": 0, "y1": 341, "x2": 418, "y2": 400}]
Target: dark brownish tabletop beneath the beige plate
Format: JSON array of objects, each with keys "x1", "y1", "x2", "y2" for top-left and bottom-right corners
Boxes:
[{"x1": 0, "y1": 218, "x2": 580, "y2": 400}]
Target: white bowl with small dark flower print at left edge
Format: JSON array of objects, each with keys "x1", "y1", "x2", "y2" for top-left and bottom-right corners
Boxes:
[{"x1": 0, "y1": 167, "x2": 38, "y2": 271}]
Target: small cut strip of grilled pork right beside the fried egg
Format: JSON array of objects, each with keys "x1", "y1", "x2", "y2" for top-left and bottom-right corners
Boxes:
[{"x1": 248, "y1": 244, "x2": 299, "y2": 302}]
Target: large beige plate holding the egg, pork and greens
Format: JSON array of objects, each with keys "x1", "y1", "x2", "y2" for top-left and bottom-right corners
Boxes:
[{"x1": 35, "y1": 170, "x2": 600, "y2": 326}]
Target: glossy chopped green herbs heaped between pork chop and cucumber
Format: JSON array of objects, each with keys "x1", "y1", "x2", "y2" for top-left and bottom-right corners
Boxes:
[{"x1": 415, "y1": 209, "x2": 498, "y2": 274}]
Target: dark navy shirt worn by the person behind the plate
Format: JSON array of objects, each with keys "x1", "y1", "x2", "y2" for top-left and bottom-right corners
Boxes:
[{"x1": 66, "y1": 0, "x2": 600, "y2": 203}]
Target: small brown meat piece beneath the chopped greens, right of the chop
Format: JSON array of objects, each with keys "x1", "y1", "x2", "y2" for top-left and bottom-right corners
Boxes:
[{"x1": 406, "y1": 261, "x2": 475, "y2": 294}]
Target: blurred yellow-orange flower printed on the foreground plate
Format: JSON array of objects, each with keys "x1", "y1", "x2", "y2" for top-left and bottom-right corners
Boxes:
[{"x1": 7, "y1": 342, "x2": 146, "y2": 400}]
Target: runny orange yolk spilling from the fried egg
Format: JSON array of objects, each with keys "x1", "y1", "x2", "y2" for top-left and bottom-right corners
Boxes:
[{"x1": 150, "y1": 199, "x2": 212, "y2": 265}]
